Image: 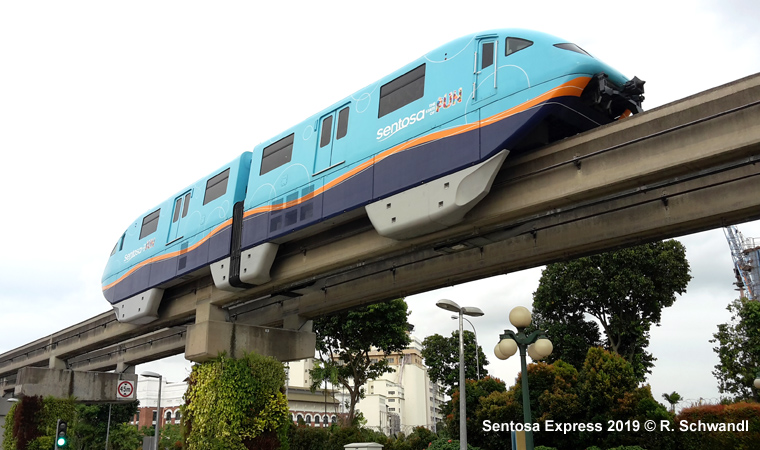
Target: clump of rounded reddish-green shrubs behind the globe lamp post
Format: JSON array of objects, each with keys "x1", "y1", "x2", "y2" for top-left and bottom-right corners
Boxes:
[{"x1": 446, "y1": 347, "x2": 675, "y2": 450}]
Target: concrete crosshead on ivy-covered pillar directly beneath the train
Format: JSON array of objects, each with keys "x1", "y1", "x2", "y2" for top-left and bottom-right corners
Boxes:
[{"x1": 185, "y1": 320, "x2": 317, "y2": 362}]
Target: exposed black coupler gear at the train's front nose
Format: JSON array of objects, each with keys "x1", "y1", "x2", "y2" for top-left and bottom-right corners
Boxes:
[{"x1": 581, "y1": 72, "x2": 645, "y2": 119}]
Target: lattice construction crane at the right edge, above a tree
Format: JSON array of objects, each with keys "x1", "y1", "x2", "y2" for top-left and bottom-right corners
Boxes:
[{"x1": 723, "y1": 225, "x2": 760, "y2": 300}]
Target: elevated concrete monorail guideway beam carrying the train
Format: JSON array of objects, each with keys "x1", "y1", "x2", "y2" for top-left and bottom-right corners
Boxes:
[{"x1": 0, "y1": 74, "x2": 760, "y2": 386}]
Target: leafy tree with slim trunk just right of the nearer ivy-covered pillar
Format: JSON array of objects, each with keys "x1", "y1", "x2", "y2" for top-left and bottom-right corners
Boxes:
[{"x1": 312, "y1": 299, "x2": 410, "y2": 423}]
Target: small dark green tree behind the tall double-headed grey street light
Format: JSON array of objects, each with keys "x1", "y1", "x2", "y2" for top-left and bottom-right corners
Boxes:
[{"x1": 422, "y1": 330, "x2": 488, "y2": 395}]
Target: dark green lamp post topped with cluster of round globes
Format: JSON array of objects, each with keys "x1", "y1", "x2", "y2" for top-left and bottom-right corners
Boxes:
[{"x1": 493, "y1": 306, "x2": 554, "y2": 450}]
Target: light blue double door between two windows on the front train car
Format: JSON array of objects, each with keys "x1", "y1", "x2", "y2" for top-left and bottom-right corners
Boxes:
[{"x1": 314, "y1": 105, "x2": 351, "y2": 175}]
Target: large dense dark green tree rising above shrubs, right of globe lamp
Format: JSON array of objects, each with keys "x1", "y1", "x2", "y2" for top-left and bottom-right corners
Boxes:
[{"x1": 533, "y1": 240, "x2": 691, "y2": 381}]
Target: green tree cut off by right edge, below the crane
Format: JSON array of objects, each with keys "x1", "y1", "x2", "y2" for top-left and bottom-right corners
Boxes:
[{"x1": 710, "y1": 298, "x2": 760, "y2": 401}]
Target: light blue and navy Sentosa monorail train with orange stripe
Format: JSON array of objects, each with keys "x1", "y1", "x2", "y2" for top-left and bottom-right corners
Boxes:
[{"x1": 102, "y1": 29, "x2": 643, "y2": 324}]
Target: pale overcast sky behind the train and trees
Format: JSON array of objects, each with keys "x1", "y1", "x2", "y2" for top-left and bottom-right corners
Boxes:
[{"x1": 0, "y1": 0, "x2": 760, "y2": 410}]
